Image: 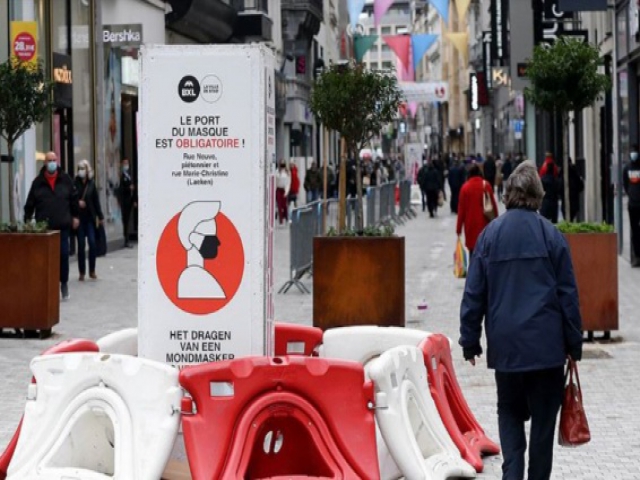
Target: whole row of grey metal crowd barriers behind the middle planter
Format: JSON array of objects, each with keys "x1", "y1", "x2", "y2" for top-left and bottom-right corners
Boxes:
[{"x1": 278, "y1": 181, "x2": 415, "y2": 293}]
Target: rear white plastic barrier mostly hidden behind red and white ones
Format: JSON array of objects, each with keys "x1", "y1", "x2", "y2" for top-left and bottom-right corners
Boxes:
[{"x1": 319, "y1": 325, "x2": 431, "y2": 480}]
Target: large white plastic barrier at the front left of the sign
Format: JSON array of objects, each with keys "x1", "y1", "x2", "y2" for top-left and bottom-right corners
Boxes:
[{"x1": 7, "y1": 353, "x2": 182, "y2": 480}]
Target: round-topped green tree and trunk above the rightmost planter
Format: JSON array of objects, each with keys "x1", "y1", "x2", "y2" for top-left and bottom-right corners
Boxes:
[{"x1": 524, "y1": 37, "x2": 611, "y2": 218}]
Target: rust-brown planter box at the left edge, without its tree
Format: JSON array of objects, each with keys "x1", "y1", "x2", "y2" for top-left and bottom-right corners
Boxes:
[{"x1": 0, "y1": 232, "x2": 60, "y2": 336}]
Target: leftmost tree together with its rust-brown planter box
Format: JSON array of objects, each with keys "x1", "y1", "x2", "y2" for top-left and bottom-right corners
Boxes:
[{"x1": 0, "y1": 58, "x2": 60, "y2": 337}]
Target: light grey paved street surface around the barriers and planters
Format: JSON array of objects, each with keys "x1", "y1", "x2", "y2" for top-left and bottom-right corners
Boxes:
[{"x1": 0, "y1": 207, "x2": 640, "y2": 480}]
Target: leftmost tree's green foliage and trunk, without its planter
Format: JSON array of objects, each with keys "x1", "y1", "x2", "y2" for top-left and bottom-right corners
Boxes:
[{"x1": 0, "y1": 59, "x2": 53, "y2": 224}]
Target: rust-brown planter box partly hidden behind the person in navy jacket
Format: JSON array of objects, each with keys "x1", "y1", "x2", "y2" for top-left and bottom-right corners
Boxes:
[{"x1": 564, "y1": 233, "x2": 618, "y2": 332}]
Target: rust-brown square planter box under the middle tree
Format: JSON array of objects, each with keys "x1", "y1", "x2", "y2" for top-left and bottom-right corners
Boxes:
[{"x1": 313, "y1": 237, "x2": 405, "y2": 330}]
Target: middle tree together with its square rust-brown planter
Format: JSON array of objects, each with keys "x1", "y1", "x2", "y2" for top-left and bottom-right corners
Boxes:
[{"x1": 310, "y1": 64, "x2": 405, "y2": 329}]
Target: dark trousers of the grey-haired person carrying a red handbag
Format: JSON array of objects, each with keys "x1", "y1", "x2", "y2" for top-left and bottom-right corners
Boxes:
[{"x1": 495, "y1": 367, "x2": 564, "y2": 480}]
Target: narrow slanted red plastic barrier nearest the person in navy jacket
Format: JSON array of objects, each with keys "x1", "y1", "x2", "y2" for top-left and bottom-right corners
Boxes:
[{"x1": 419, "y1": 334, "x2": 500, "y2": 473}]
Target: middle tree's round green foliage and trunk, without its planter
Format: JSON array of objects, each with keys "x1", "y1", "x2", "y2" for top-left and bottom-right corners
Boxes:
[{"x1": 309, "y1": 63, "x2": 402, "y2": 233}]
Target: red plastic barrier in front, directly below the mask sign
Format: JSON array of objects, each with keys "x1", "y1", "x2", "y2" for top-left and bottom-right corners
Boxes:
[{"x1": 180, "y1": 357, "x2": 380, "y2": 480}]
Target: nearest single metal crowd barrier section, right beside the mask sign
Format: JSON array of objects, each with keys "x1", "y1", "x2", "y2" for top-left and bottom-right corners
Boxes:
[{"x1": 278, "y1": 201, "x2": 322, "y2": 293}]
